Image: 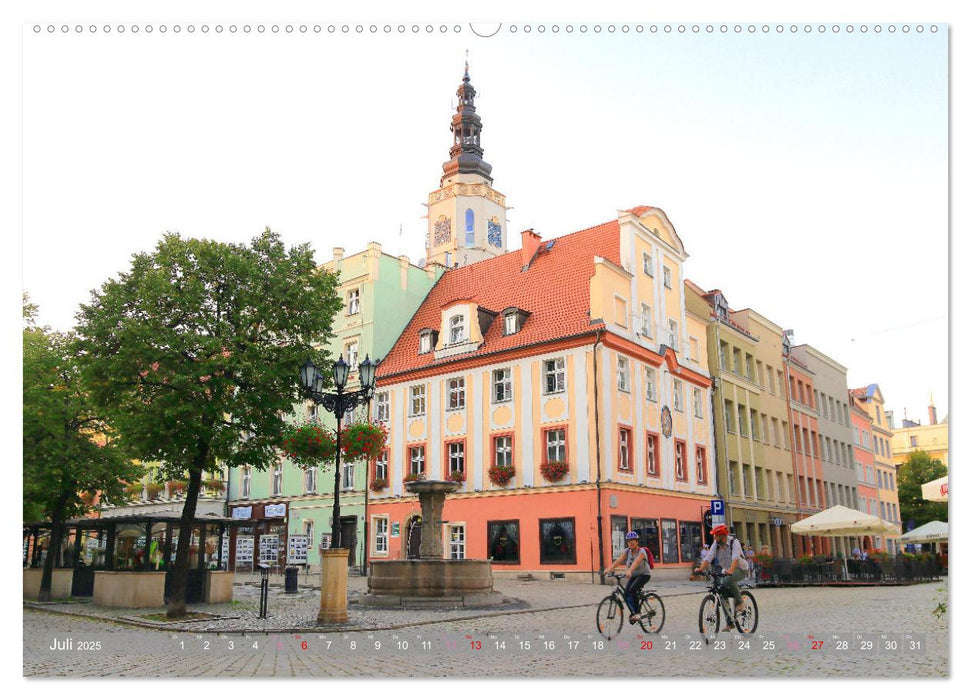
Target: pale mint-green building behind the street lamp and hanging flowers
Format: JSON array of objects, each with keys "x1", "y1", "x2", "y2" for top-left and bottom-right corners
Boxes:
[{"x1": 227, "y1": 243, "x2": 444, "y2": 572}]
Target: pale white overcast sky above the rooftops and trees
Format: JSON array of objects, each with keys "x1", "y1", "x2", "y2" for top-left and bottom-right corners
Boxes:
[{"x1": 23, "y1": 23, "x2": 948, "y2": 425}]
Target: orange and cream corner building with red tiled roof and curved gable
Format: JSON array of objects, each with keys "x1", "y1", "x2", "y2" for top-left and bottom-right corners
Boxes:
[{"x1": 369, "y1": 207, "x2": 715, "y2": 580}]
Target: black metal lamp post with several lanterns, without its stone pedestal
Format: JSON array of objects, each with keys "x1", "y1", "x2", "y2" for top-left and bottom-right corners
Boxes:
[{"x1": 300, "y1": 356, "x2": 378, "y2": 549}]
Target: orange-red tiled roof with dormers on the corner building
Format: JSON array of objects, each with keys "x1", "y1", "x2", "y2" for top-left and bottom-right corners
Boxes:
[{"x1": 377, "y1": 220, "x2": 620, "y2": 378}]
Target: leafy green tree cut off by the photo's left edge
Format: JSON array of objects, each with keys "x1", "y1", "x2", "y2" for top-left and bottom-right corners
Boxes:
[{"x1": 23, "y1": 295, "x2": 140, "y2": 600}]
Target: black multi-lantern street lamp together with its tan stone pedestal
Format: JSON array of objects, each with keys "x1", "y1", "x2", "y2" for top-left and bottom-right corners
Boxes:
[{"x1": 300, "y1": 357, "x2": 377, "y2": 623}]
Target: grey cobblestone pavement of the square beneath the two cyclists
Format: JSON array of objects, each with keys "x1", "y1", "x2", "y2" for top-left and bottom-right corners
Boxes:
[{"x1": 24, "y1": 581, "x2": 949, "y2": 678}]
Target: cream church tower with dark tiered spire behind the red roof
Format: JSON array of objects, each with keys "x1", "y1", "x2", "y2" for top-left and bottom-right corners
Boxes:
[{"x1": 426, "y1": 62, "x2": 506, "y2": 267}]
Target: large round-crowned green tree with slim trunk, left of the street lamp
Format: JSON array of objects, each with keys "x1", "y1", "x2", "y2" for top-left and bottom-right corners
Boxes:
[{"x1": 78, "y1": 229, "x2": 342, "y2": 618}]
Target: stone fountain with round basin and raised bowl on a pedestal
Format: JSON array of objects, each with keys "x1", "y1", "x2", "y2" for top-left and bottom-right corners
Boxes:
[{"x1": 358, "y1": 481, "x2": 504, "y2": 607}]
